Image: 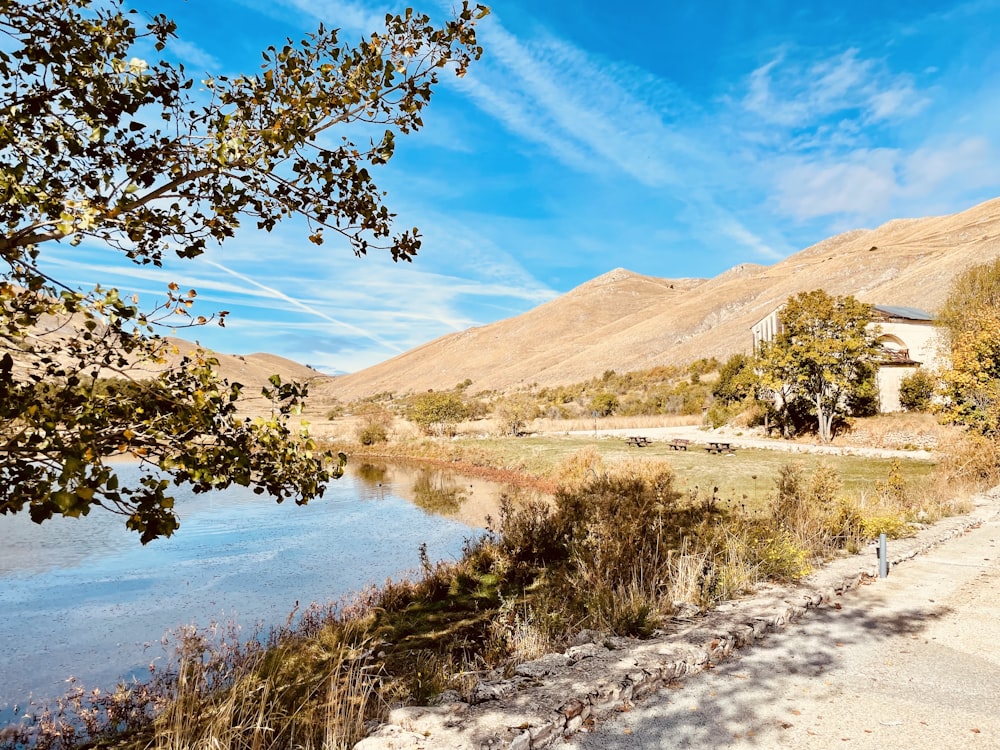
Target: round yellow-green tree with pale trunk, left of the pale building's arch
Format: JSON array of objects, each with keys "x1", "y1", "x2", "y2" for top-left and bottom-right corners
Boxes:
[{"x1": 758, "y1": 289, "x2": 879, "y2": 441}]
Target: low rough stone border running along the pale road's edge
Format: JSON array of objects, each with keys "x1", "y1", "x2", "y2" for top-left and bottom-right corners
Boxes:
[{"x1": 354, "y1": 487, "x2": 1000, "y2": 750}]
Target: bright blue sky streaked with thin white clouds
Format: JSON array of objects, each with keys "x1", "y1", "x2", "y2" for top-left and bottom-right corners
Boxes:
[{"x1": 48, "y1": 0, "x2": 1000, "y2": 372}]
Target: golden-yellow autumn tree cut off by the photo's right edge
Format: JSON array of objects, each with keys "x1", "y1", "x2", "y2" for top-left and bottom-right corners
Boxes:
[{"x1": 938, "y1": 259, "x2": 1000, "y2": 437}]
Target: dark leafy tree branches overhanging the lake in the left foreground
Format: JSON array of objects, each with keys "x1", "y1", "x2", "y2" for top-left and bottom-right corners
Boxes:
[{"x1": 0, "y1": 0, "x2": 488, "y2": 542}]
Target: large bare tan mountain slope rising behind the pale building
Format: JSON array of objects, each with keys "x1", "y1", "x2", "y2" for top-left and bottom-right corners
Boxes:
[{"x1": 314, "y1": 199, "x2": 1000, "y2": 400}]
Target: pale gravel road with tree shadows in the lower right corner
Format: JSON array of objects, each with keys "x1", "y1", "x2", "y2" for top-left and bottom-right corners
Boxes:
[{"x1": 572, "y1": 508, "x2": 1000, "y2": 750}]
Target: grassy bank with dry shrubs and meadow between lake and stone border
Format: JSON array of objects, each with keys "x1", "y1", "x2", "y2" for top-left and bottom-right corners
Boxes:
[{"x1": 7, "y1": 428, "x2": 998, "y2": 748}]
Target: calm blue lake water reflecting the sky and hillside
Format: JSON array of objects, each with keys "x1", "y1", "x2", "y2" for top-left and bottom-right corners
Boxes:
[{"x1": 0, "y1": 464, "x2": 502, "y2": 712}]
